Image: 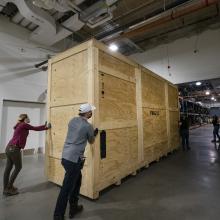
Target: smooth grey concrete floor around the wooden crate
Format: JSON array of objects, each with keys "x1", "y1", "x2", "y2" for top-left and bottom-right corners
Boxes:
[{"x1": 0, "y1": 126, "x2": 220, "y2": 220}]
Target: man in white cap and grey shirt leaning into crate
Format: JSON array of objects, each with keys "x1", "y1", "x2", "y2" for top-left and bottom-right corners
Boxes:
[{"x1": 54, "y1": 103, "x2": 98, "y2": 220}]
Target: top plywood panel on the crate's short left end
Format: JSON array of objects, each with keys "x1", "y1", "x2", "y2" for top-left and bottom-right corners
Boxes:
[{"x1": 50, "y1": 50, "x2": 89, "y2": 106}]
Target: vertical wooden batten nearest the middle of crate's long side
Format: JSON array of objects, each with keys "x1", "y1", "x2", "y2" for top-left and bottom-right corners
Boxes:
[{"x1": 135, "y1": 68, "x2": 144, "y2": 163}]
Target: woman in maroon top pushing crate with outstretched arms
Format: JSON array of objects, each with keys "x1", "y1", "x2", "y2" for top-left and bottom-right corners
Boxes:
[{"x1": 3, "y1": 114, "x2": 51, "y2": 196}]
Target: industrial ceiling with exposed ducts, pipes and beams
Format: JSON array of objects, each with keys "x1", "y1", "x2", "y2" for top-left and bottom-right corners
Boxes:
[{"x1": 0, "y1": 0, "x2": 220, "y2": 105}]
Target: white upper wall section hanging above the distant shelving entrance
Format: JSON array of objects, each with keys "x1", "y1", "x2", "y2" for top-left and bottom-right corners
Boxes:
[{"x1": 131, "y1": 29, "x2": 220, "y2": 84}]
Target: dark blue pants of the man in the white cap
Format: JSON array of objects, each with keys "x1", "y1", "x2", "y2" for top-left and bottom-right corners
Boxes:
[{"x1": 54, "y1": 159, "x2": 82, "y2": 216}]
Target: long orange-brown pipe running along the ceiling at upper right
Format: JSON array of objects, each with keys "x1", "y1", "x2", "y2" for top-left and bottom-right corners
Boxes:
[{"x1": 105, "y1": 0, "x2": 219, "y2": 43}]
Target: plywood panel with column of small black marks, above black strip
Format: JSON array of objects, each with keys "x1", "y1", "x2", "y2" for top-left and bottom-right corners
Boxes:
[{"x1": 99, "y1": 73, "x2": 137, "y2": 123}]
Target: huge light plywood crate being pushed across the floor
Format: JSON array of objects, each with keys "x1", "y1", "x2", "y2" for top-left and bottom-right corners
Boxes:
[{"x1": 46, "y1": 40, "x2": 179, "y2": 199}]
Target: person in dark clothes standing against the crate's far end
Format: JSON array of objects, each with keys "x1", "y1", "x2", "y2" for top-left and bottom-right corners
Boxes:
[{"x1": 180, "y1": 115, "x2": 190, "y2": 151}]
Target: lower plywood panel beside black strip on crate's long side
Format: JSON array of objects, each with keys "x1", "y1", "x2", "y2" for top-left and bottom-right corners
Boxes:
[{"x1": 99, "y1": 127, "x2": 138, "y2": 190}]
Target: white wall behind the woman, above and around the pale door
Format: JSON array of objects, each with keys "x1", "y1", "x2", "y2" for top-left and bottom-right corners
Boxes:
[{"x1": 0, "y1": 23, "x2": 48, "y2": 153}]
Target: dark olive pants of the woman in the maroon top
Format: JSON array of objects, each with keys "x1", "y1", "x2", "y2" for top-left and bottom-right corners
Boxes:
[{"x1": 4, "y1": 146, "x2": 22, "y2": 189}]
